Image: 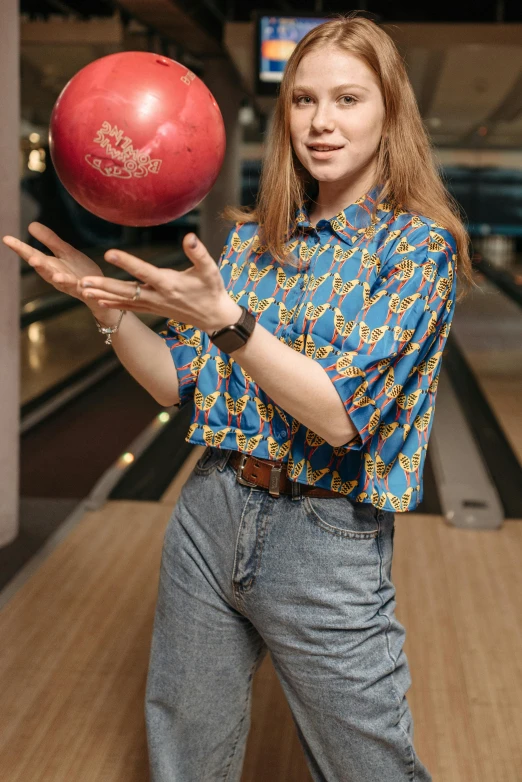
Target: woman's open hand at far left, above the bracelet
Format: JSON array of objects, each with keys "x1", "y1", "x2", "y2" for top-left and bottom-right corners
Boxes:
[{"x1": 2, "y1": 223, "x2": 103, "y2": 302}]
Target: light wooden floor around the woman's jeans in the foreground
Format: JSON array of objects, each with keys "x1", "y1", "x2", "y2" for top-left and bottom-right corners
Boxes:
[{"x1": 0, "y1": 448, "x2": 522, "y2": 782}]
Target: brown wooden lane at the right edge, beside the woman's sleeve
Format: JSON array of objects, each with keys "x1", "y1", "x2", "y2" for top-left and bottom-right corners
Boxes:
[{"x1": 451, "y1": 274, "x2": 522, "y2": 464}]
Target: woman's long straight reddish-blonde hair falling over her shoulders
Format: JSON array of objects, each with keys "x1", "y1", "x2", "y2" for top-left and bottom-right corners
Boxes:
[{"x1": 222, "y1": 11, "x2": 473, "y2": 300}]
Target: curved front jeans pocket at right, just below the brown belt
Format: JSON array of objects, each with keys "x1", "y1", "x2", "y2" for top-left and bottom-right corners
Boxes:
[{"x1": 303, "y1": 495, "x2": 380, "y2": 540}]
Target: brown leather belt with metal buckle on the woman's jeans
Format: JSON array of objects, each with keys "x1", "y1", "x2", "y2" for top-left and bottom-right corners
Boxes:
[{"x1": 228, "y1": 451, "x2": 343, "y2": 499}]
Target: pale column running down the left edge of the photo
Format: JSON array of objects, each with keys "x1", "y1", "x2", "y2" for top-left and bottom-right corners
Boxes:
[{"x1": 0, "y1": 0, "x2": 22, "y2": 546}]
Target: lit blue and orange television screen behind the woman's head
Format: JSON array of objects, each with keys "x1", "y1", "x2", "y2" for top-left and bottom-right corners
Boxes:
[{"x1": 258, "y1": 16, "x2": 328, "y2": 92}]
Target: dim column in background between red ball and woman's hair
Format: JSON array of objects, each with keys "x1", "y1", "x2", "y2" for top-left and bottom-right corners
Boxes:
[{"x1": 199, "y1": 57, "x2": 244, "y2": 261}]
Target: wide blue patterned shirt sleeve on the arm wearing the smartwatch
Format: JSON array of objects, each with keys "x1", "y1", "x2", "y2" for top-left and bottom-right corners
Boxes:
[{"x1": 314, "y1": 219, "x2": 457, "y2": 450}]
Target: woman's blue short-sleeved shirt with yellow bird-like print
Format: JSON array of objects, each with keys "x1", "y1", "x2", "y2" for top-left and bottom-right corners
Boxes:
[{"x1": 161, "y1": 189, "x2": 457, "y2": 511}]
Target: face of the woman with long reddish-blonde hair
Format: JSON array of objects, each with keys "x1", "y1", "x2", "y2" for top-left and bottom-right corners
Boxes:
[{"x1": 290, "y1": 47, "x2": 384, "y2": 184}]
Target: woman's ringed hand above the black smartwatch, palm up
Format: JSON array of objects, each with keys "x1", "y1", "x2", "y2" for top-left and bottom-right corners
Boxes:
[{"x1": 75, "y1": 234, "x2": 241, "y2": 333}]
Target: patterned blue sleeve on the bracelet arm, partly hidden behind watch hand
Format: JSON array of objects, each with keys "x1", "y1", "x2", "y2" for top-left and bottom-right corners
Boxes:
[{"x1": 159, "y1": 229, "x2": 235, "y2": 406}]
